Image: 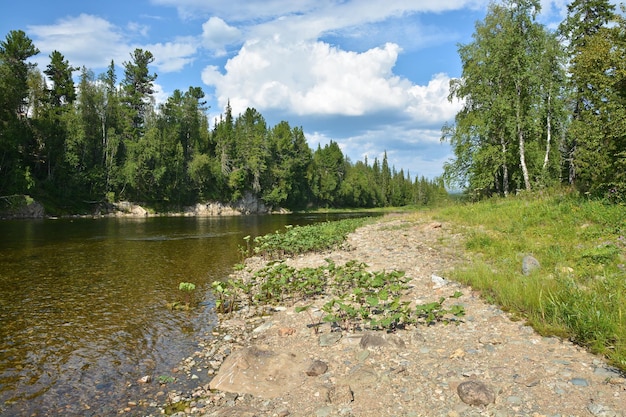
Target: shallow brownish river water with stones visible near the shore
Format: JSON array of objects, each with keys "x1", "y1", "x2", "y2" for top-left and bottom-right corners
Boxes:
[{"x1": 0, "y1": 214, "x2": 370, "y2": 416}]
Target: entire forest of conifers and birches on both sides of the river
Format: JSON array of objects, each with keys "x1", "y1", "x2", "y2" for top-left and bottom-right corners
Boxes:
[{"x1": 0, "y1": 0, "x2": 626, "y2": 209}]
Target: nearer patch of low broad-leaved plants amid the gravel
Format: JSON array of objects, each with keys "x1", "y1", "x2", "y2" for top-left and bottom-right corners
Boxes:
[{"x1": 213, "y1": 254, "x2": 465, "y2": 332}]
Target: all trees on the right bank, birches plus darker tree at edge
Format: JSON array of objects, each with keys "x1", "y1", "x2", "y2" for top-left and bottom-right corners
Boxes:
[{"x1": 442, "y1": 0, "x2": 626, "y2": 204}]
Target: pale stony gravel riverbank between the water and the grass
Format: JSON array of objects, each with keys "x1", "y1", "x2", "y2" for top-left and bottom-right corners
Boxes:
[{"x1": 127, "y1": 214, "x2": 626, "y2": 416}]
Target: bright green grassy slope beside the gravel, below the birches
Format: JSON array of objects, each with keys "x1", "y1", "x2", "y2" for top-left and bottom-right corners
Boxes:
[{"x1": 434, "y1": 192, "x2": 626, "y2": 370}]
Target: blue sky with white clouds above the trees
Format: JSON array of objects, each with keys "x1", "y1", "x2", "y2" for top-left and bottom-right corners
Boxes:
[{"x1": 0, "y1": 0, "x2": 567, "y2": 179}]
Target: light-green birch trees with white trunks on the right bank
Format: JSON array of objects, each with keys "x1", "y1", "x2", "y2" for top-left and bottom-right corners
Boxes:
[{"x1": 442, "y1": 0, "x2": 566, "y2": 197}]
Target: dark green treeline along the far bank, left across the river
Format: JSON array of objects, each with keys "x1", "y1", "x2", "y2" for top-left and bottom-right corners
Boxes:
[{"x1": 0, "y1": 30, "x2": 447, "y2": 209}]
